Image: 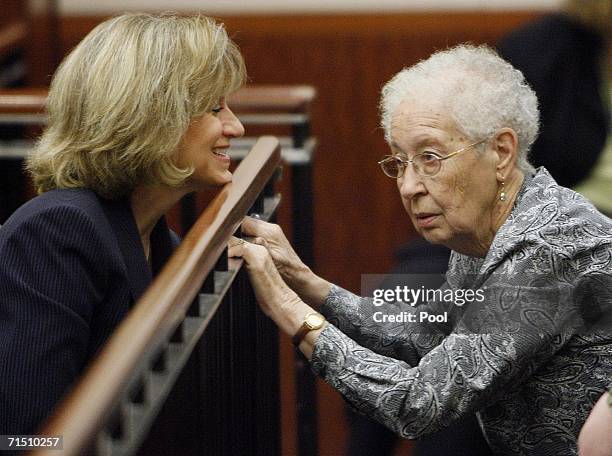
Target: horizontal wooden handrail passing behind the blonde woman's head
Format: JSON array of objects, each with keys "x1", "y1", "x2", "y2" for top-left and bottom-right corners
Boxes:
[{"x1": 0, "y1": 85, "x2": 316, "y2": 114}]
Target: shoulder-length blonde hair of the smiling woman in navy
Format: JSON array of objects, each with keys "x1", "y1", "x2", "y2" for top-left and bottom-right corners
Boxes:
[{"x1": 27, "y1": 13, "x2": 246, "y2": 199}]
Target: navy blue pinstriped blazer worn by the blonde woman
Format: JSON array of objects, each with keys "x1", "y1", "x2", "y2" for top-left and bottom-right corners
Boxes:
[{"x1": 0, "y1": 189, "x2": 178, "y2": 434}]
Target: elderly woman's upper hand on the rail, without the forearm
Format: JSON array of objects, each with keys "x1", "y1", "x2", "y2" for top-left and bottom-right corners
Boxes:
[{"x1": 242, "y1": 217, "x2": 310, "y2": 289}]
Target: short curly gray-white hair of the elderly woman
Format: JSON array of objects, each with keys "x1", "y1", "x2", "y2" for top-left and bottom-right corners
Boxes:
[{"x1": 380, "y1": 44, "x2": 540, "y2": 173}]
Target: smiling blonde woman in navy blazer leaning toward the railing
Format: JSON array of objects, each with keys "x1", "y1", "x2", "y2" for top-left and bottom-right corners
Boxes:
[{"x1": 0, "y1": 14, "x2": 245, "y2": 434}]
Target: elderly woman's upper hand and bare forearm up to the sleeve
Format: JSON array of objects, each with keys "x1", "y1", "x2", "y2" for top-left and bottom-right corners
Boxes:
[{"x1": 242, "y1": 217, "x2": 331, "y2": 307}]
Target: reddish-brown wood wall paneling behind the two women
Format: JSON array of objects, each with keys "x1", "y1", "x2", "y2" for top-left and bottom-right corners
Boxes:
[{"x1": 43, "y1": 12, "x2": 537, "y2": 455}]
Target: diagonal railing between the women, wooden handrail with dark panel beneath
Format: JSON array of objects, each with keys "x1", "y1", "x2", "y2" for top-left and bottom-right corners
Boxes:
[{"x1": 29, "y1": 137, "x2": 281, "y2": 455}]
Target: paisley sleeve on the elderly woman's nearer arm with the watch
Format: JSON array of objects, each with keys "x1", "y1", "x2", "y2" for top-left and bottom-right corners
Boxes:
[{"x1": 312, "y1": 270, "x2": 592, "y2": 439}]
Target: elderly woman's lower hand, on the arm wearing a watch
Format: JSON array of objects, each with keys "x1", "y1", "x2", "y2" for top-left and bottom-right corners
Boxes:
[{"x1": 228, "y1": 237, "x2": 301, "y2": 320}]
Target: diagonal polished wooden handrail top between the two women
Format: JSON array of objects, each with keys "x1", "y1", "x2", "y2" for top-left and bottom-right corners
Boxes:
[{"x1": 34, "y1": 137, "x2": 280, "y2": 456}]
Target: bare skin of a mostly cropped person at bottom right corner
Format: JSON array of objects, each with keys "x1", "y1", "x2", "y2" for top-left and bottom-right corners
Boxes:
[{"x1": 578, "y1": 392, "x2": 612, "y2": 456}]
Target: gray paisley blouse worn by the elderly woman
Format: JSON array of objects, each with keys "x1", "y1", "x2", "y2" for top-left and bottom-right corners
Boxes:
[{"x1": 311, "y1": 168, "x2": 612, "y2": 456}]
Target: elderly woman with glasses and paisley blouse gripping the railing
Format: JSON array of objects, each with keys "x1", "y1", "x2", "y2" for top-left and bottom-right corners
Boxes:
[{"x1": 230, "y1": 46, "x2": 612, "y2": 455}]
